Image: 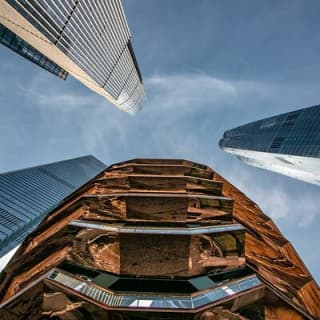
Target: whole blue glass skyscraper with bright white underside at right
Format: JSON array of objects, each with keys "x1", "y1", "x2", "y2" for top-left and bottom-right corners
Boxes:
[{"x1": 220, "y1": 105, "x2": 320, "y2": 185}]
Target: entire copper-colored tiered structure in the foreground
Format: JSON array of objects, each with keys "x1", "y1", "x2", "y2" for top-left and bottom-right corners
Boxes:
[{"x1": 0, "y1": 159, "x2": 320, "y2": 320}]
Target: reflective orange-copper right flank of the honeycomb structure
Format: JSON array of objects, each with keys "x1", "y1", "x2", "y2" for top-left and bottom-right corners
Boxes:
[{"x1": 214, "y1": 174, "x2": 320, "y2": 317}]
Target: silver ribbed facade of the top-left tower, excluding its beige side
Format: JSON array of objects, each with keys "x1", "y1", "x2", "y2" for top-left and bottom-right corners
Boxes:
[{"x1": 8, "y1": 0, "x2": 144, "y2": 111}]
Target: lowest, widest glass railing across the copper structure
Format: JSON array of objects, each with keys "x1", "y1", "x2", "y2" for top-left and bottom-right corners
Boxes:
[{"x1": 48, "y1": 269, "x2": 262, "y2": 309}]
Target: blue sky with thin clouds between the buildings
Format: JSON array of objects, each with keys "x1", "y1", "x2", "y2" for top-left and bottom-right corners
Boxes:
[{"x1": 0, "y1": 0, "x2": 320, "y2": 283}]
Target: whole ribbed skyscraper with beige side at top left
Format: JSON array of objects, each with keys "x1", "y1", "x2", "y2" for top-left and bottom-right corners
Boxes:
[{"x1": 0, "y1": 0, "x2": 144, "y2": 113}]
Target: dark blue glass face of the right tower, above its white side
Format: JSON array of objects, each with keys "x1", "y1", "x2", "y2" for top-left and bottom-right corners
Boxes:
[{"x1": 220, "y1": 105, "x2": 320, "y2": 157}]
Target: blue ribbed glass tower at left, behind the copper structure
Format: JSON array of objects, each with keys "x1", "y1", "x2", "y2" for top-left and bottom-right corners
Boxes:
[{"x1": 0, "y1": 156, "x2": 106, "y2": 257}]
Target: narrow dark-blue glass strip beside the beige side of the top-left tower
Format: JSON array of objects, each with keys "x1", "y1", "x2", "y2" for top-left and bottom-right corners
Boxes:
[{"x1": 0, "y1": 24, "x2": 68, "y2": 80}]
